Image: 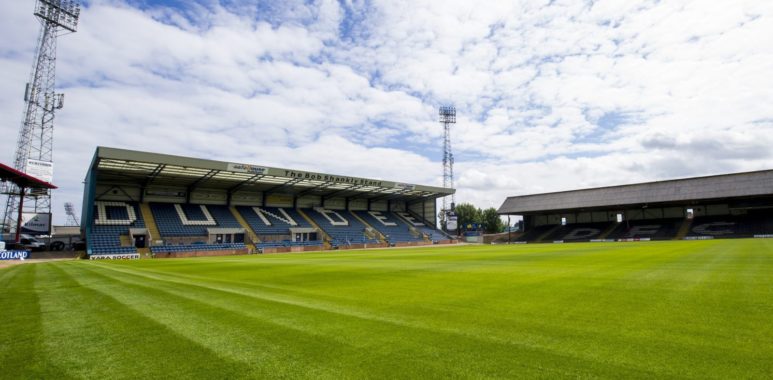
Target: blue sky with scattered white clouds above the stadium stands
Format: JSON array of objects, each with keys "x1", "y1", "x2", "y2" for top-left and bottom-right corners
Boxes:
[{"x1": 0, "y1": 0, "x2": 773, "y2": 224}]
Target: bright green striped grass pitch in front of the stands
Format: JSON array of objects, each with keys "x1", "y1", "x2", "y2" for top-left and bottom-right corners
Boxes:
[{"x1": 0, "y1": 239, "x2": 773, "y2": 379}]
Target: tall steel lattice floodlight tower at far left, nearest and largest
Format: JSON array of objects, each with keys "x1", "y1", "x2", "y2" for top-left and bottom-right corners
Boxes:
[{"x1": 3, "y1": 0, "x2": 81, "y2": 230}]
